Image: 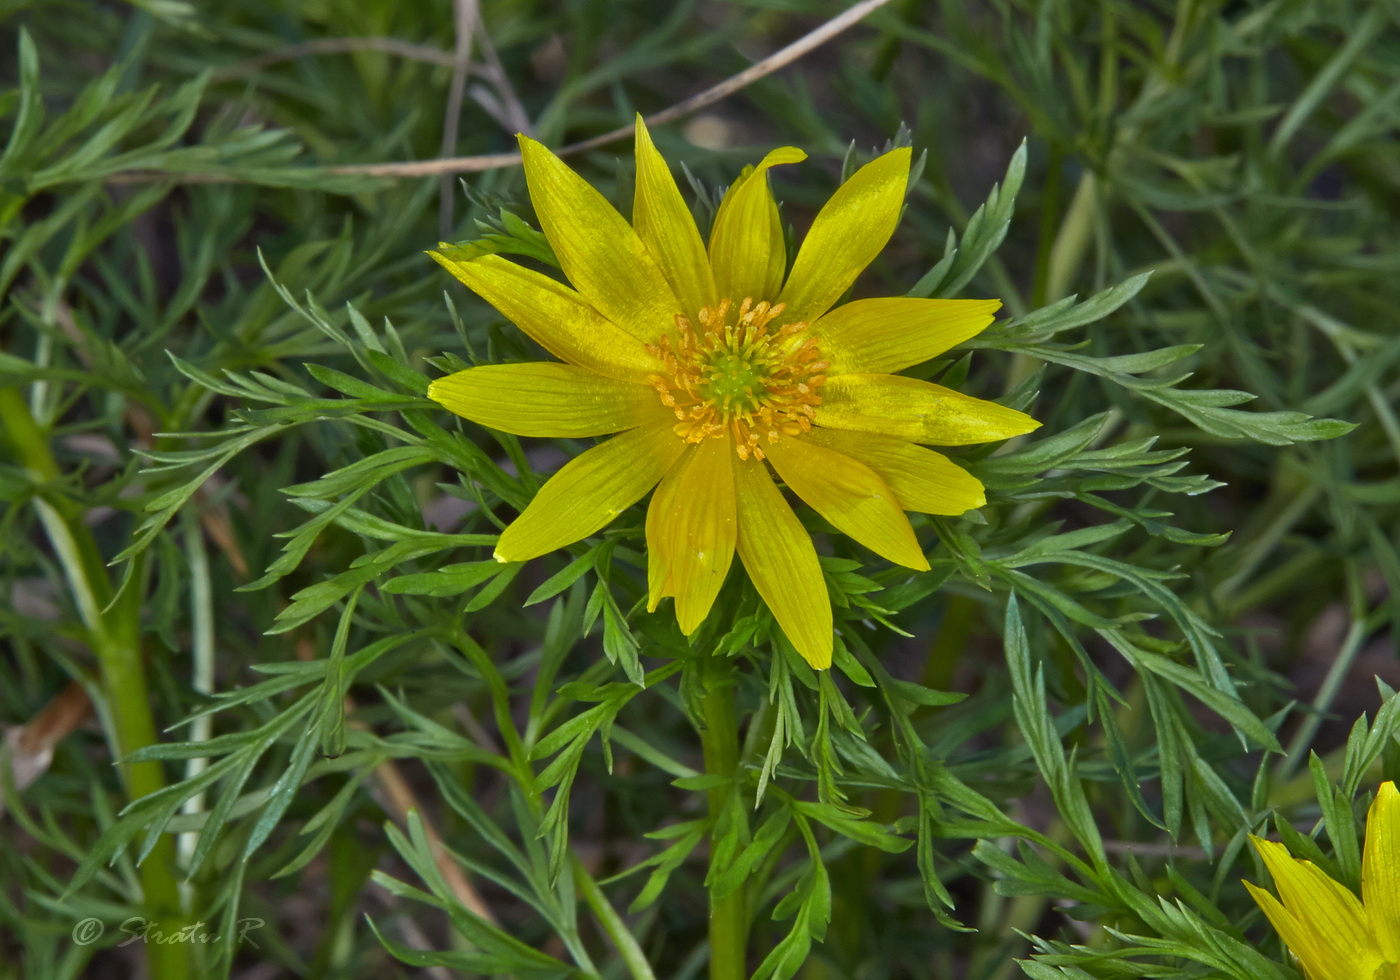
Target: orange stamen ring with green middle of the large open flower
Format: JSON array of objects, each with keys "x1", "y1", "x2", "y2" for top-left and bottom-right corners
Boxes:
[{"x1": 647, "y1": 298, "x2": 830, "y2": 459}]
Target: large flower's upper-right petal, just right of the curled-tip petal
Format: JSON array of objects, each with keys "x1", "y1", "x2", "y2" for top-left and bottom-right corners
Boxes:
[{"x1": 778, "y1": 147, "x2": 910, "y2": 323}]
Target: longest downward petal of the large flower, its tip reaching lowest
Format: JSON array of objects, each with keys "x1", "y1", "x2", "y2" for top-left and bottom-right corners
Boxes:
[{"x1": 734, "y1": 459, "x2": 833, "y2": 671}]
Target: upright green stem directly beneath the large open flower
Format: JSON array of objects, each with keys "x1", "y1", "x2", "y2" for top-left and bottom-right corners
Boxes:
[{"x1": 700, "y1": 654, "x2": 749, "y2": 980}]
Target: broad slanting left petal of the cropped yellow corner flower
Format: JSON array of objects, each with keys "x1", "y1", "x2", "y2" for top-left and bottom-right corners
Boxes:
[{"x1": 1253, "y1": 839, "x2": 1383, "y2": 980}]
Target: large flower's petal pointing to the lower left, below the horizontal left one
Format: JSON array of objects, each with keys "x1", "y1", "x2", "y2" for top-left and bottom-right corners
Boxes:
[{"x1": 496, "y1": 419, "x2": 685, "y2": 561}]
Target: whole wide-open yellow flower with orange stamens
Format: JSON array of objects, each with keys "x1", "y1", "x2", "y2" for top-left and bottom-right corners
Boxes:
[{"x1": 430, "y1": 119, "x2": 1039, "y2": 669}]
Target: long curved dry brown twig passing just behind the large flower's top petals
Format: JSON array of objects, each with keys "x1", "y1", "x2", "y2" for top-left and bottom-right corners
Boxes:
[{"x1": 108, "y1": 0, "x2": 889, "y2": 183}]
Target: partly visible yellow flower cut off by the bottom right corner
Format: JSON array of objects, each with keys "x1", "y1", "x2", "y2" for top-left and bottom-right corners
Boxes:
[{"x1": 1245, "y1": 783, "x2": 1400, "y2": 980}]
